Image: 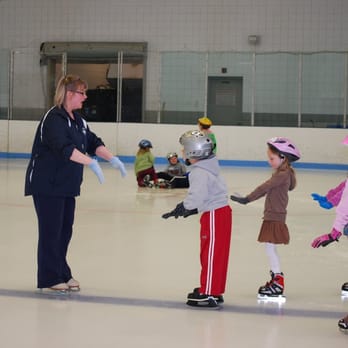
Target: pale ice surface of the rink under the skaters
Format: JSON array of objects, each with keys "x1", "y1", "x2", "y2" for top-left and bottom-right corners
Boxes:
[{"x1": 0, "y1": 159, "x2": 348, "y2": 348}]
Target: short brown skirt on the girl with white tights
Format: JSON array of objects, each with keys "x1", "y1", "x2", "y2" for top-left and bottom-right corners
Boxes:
[{"x1": 257, "y1": 221, "x2": 290, "y2": 244}]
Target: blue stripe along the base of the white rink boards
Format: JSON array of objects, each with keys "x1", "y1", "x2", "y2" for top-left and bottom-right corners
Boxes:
[{"x1": 0, "y1": 152, "x2": 348, "y2": 171}]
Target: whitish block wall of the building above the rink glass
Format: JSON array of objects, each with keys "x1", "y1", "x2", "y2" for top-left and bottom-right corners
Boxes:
[{"x1": 0, "y1": 0, "x2": 348, "y2": 112}]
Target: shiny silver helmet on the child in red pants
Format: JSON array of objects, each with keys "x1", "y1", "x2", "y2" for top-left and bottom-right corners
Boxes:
[{"x1": 179, "y1": 130, "x2": 213, "y2": 159}]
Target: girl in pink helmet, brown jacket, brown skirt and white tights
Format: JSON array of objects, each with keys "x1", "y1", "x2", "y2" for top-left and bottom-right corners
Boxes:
[{"x1": 231, "y1": 137, "x2": 300, "y2": 299}]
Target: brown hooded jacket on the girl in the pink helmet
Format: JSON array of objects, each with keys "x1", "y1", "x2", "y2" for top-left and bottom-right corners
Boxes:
[{"x1": 247, "y1": 166, "x2": 296, "y2": 223}]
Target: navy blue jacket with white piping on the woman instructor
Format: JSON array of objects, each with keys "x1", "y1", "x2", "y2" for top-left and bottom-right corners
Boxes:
[{"x1": 24, "y1": 107, "x2": 104, "y2": 197}]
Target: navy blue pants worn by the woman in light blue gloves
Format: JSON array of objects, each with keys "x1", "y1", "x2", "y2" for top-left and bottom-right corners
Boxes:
[{"x1": 33, "y1": 195, "x2": 75, "y2": 288}]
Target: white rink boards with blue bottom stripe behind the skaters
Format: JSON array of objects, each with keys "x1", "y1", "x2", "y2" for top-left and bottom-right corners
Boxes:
[{"x1": 0, "y1": 120, "x2": 348, "y2": 170}]
